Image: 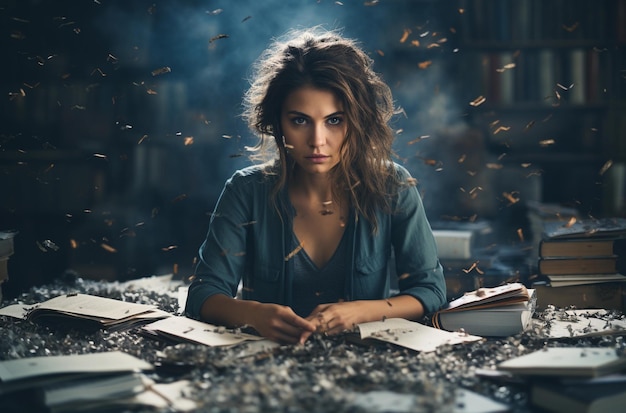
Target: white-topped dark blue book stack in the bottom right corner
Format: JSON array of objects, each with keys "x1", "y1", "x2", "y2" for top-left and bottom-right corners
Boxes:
[{"x1": 498, "y1": 347, "x2": 626, "y2": 413}]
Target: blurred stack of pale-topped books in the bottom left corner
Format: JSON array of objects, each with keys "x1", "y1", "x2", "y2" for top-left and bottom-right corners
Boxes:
[{"x1": 0, "y1": 351, "x2": 197, "y2": 413}]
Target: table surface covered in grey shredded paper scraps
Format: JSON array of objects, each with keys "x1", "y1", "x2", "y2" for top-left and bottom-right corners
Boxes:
[{"x1": 0, "y1": 278, "x2": 626, "y2": 412}]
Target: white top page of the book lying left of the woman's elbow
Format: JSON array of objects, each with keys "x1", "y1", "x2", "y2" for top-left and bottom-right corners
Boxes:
[{"x1": 34, "y1": 294, "x2": 156, "y2": 320}]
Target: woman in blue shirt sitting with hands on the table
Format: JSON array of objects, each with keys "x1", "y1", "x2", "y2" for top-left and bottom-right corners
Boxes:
[{"x1": 186, "y1": 26, "x2": 446, "y2": 343}]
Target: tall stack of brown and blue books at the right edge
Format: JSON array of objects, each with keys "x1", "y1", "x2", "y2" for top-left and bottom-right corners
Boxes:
[{"x1": 533, "y1": 218, "x2": 626, "y2": 309}]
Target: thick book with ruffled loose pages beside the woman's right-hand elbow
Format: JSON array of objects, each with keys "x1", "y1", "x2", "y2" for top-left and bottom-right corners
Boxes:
[{"x1": 432, "y1": 283, "x2": 536, "y2": 337}]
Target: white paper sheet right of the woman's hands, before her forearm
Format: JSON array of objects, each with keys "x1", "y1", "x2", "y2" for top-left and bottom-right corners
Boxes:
[{"x1": 358, "y1": 318, "x2": 482, "y2": 352}]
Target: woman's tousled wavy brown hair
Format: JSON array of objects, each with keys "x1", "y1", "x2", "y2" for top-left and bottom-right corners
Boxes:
[{"x1": 243, "y1": 27, "x2": 397, "y2": 231}]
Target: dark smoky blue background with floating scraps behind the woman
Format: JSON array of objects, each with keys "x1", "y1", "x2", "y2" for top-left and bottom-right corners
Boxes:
[{"x1": 0, "y1": 0, "x2": 626, "y2": 296}]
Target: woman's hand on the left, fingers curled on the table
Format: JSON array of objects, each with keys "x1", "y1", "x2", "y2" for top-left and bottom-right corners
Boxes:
[{"x1": 251, "y1": 303, "x2": 316, "y2": 344}]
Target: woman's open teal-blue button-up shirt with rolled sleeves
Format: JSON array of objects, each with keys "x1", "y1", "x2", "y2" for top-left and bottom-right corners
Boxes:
[{"x1": 185, "y1": 163, "x2": 446, "y2": 318}]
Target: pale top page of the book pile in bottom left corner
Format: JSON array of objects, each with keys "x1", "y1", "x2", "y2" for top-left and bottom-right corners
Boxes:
[{"x1": 0, "y1": 351, "x2": 153, "y2": 382}]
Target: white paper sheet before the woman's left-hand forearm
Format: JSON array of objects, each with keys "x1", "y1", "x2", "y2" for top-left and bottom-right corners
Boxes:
[{"x1": 143, "y1": 316, "x2": 263, "y2": 347}]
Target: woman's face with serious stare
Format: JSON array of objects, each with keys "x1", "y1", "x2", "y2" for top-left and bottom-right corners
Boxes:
[{"x1": 281, "y1": 86, "x2": 348, "y2": 174}]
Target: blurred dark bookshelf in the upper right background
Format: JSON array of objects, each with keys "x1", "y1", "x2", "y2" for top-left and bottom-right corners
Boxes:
[{"x1": 451, "y1": 0, "x2": 626, "y2": 215}]
